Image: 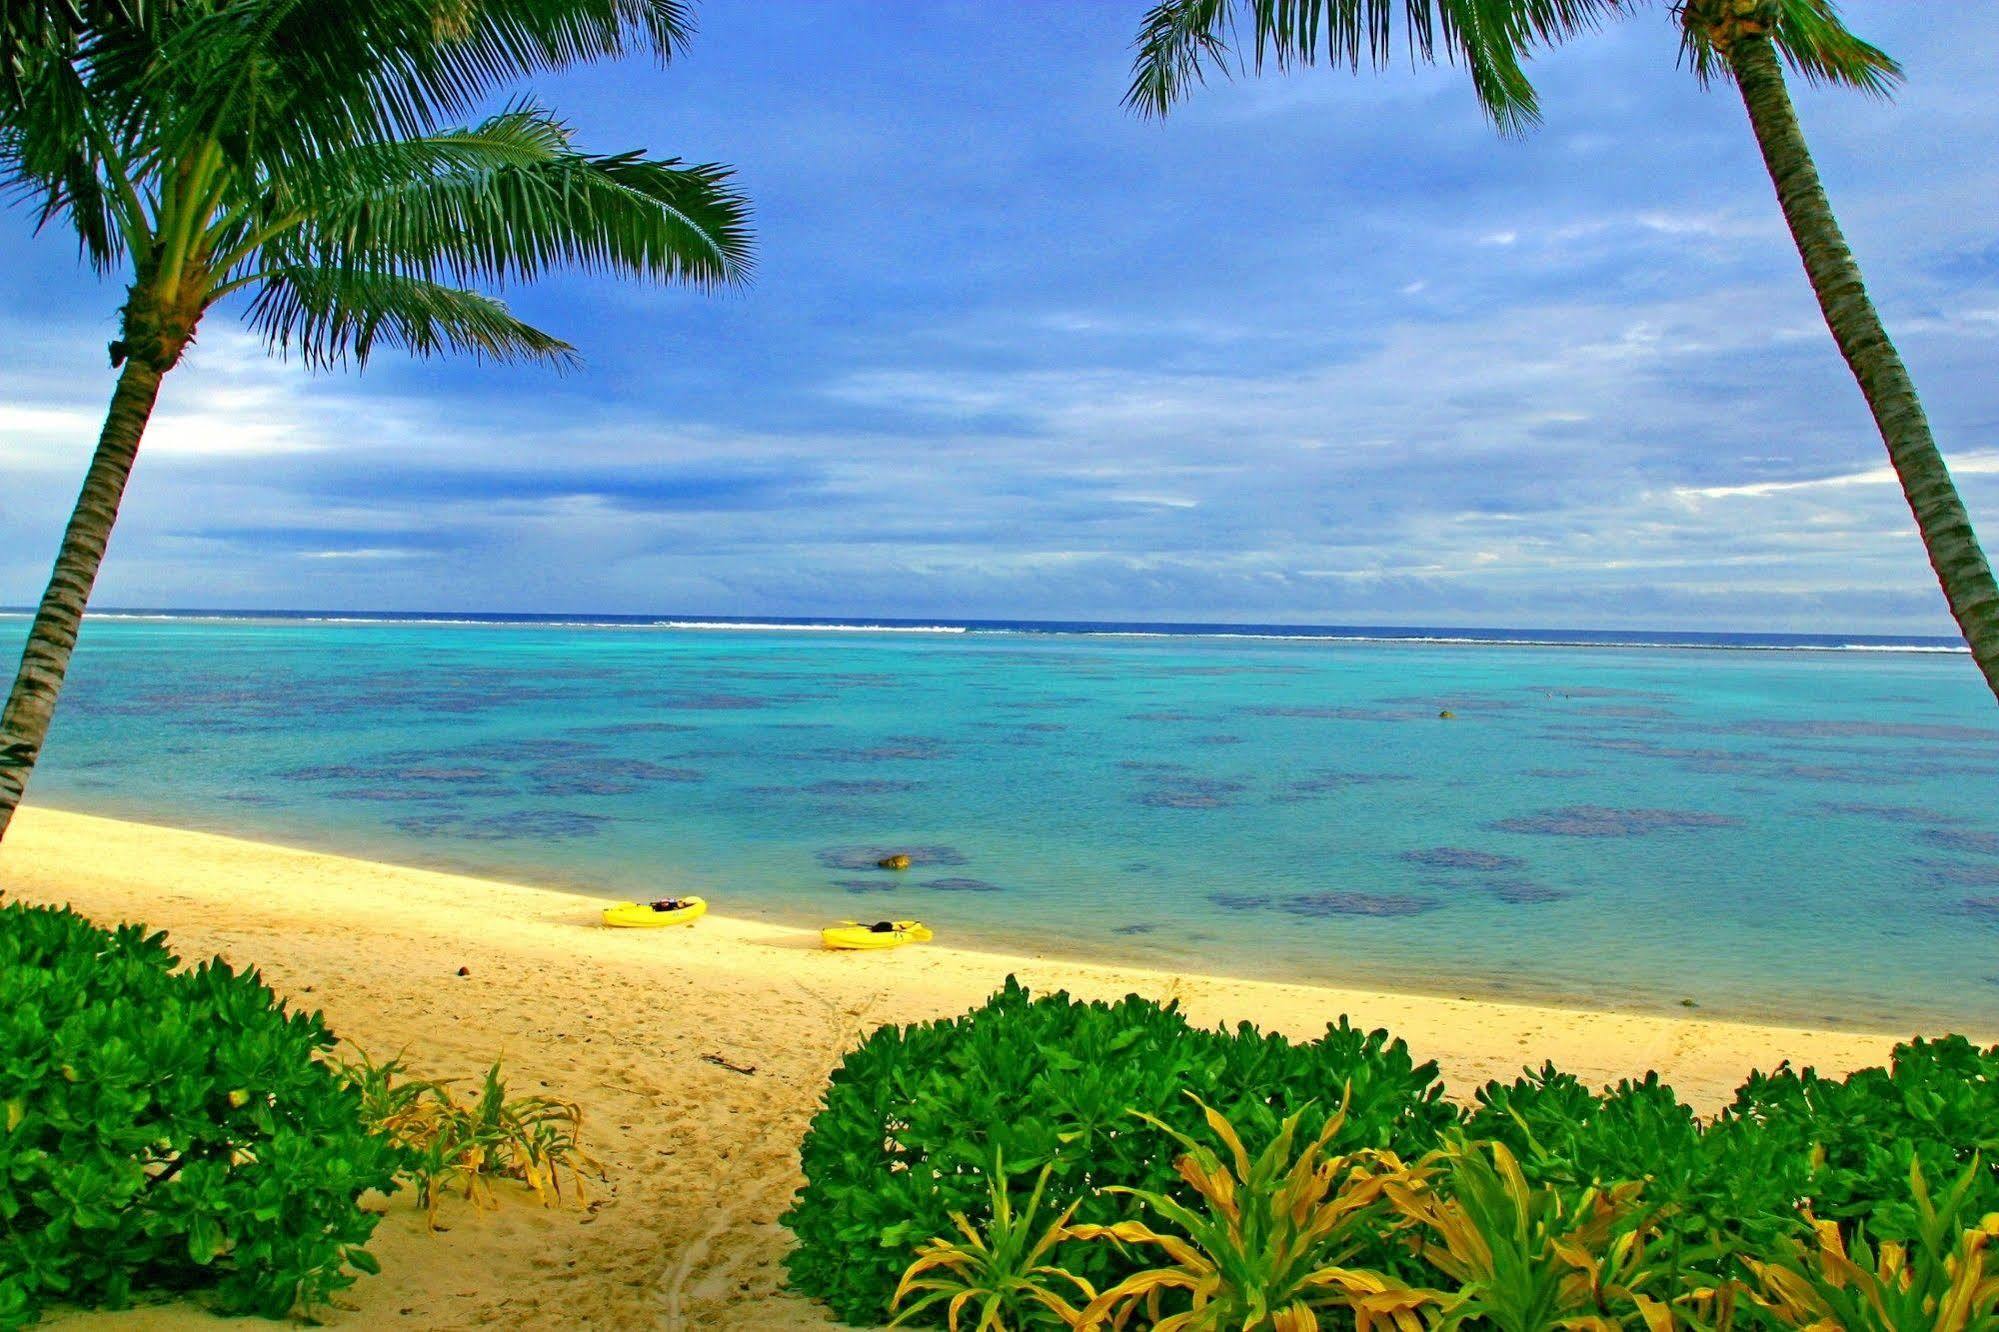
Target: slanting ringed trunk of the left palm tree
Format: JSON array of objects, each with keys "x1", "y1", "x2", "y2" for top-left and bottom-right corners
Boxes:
[{"x1": 0, "y1": 356, "x2": 164, "y2": 838}]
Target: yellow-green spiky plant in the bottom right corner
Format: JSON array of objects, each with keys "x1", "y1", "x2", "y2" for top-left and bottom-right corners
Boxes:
[{"x1": 1747, "y1": 1160, "x2": 1999, "y2": 1332}]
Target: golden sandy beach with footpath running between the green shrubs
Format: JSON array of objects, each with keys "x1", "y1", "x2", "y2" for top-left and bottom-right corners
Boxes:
[{"x1": 0, "y1": 808, "x2": 1935, "y2": 1330}]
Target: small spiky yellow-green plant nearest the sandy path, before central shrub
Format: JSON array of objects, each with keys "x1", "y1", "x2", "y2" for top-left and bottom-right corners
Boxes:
[{"x1": 892, "y1": 1158, "x2": 1097, "y2": 1332}]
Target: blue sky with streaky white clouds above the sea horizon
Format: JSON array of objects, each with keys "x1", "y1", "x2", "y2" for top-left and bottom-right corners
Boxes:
[{"x1": 0, "y1": 0, "x2": 1999, "y2": 632}]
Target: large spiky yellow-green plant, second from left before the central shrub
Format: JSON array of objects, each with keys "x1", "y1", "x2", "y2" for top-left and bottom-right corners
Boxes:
[{"x1": 1069, "y1": 1098, "x2": 1437, "y2": 1332}]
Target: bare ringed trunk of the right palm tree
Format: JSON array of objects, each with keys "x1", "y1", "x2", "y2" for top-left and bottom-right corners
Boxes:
[{"x1": 1727, "y1": 32, "x2": 1999, "y2": 696}]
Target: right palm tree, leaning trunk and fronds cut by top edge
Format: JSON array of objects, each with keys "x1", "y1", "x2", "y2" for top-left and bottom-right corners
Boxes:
[{"x1": 1125, "y1": 0, "x2": 1999, "y2": 696}]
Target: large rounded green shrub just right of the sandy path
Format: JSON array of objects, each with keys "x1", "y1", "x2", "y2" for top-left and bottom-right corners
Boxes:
[{"x1": 786, "y1": 978, "x2": 1457, "y2": 1322}]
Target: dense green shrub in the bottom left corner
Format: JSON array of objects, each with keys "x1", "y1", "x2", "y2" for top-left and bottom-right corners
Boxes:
[{"x1": 0, "y1": 904, "x2": 396, "y2": 1326}]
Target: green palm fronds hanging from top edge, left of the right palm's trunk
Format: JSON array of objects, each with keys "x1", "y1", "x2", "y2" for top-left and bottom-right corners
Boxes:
[{"x1": 1125, "y1": 0, "x2": 1617, "y2": 130}]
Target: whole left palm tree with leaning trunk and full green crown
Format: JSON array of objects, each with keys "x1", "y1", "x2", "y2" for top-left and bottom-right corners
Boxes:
[{"x1": 0, "y1": 0, "x2": 750, "y2": 836}]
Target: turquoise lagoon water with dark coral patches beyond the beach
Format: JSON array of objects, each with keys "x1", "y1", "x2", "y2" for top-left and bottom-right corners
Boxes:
[{"x1": 15, "y1": 618, "x2": 1999, "y2": 1032}]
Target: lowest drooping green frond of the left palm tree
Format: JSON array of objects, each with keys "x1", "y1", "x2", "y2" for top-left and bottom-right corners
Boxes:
[{"x1": 248, "y1": 268, "x2": 576, "y2": 368}]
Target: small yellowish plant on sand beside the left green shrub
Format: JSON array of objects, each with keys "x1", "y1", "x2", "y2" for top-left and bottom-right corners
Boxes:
[{"x1": 336, "y1": 1052, "x2": 604, "y2": 1228}]
